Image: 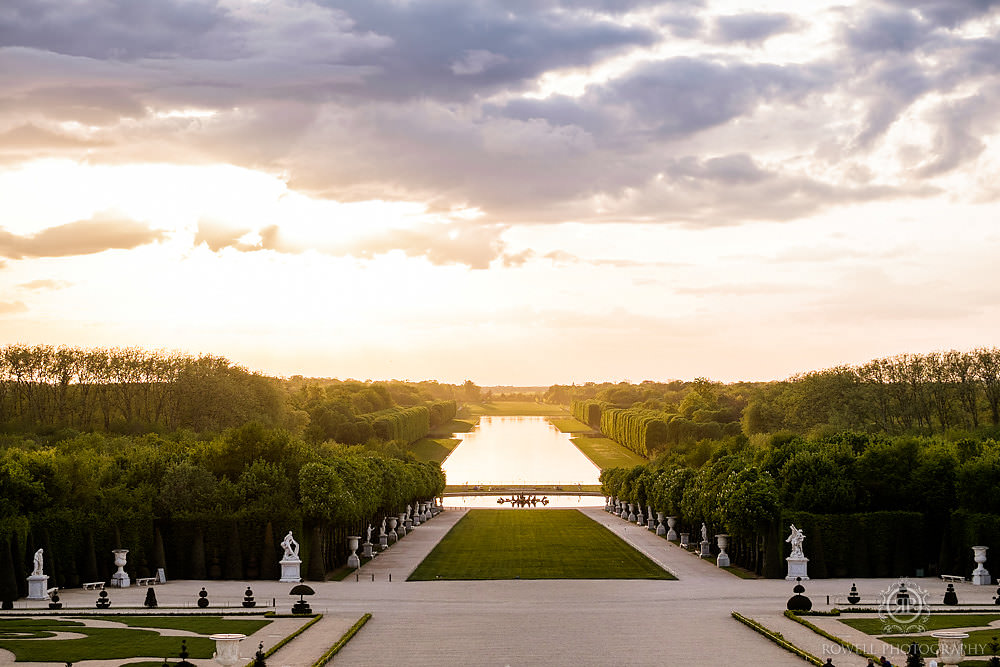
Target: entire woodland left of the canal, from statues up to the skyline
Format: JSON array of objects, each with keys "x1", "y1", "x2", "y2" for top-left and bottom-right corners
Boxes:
[{"x1": 0, "y1": 346, "x2": 454, "y2": 600}]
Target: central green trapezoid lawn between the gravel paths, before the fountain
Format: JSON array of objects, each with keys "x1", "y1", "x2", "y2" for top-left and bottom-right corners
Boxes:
[{"x1": 410, "y1": 509, "x2": 674, "y2": 581}]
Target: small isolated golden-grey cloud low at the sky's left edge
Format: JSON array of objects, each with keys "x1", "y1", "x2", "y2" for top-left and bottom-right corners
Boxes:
[{"x1": 0, "y1": 213, "x2": 166, "y2": 259}]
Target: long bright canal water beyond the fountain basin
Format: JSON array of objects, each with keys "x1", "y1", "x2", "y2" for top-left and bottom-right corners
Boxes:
[{"x1": 441, "y1": 417, "x2": 601, "y2": 486}]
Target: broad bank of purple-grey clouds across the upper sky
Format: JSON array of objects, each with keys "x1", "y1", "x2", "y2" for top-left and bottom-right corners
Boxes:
[{"x1": 0, "y1": 0, "x2": 1000, "y2": 231}]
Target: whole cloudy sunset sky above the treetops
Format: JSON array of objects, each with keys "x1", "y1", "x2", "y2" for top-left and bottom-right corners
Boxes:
[{"x1": 0, "y1": 0, "x2": 1000, "y2": 385}]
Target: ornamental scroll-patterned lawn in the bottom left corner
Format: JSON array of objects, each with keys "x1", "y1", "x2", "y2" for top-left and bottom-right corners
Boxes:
[{"x1": 0, "y1": 616, "x2": 271, "y2": 664}]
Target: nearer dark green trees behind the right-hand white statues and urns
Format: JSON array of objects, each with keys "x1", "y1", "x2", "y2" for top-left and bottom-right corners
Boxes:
[{"x1": 601, "y1": 432, "x2": 1000, "y2": 577}]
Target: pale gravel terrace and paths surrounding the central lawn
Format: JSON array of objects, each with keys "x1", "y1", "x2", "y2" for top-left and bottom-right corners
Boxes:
[{"x1": 0, "y1": 508, "x2": 994, "y2": 667}]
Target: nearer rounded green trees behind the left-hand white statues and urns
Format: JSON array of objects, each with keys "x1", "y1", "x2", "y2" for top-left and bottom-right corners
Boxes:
[{"x1": 0, "y1": 423, "x2": 445, "y2": 600}]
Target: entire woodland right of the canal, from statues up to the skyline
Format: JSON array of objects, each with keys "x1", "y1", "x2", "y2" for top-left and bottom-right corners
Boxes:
[{"x1": 588, "y1": 348, "x2": 1000, "y2": 577}]
